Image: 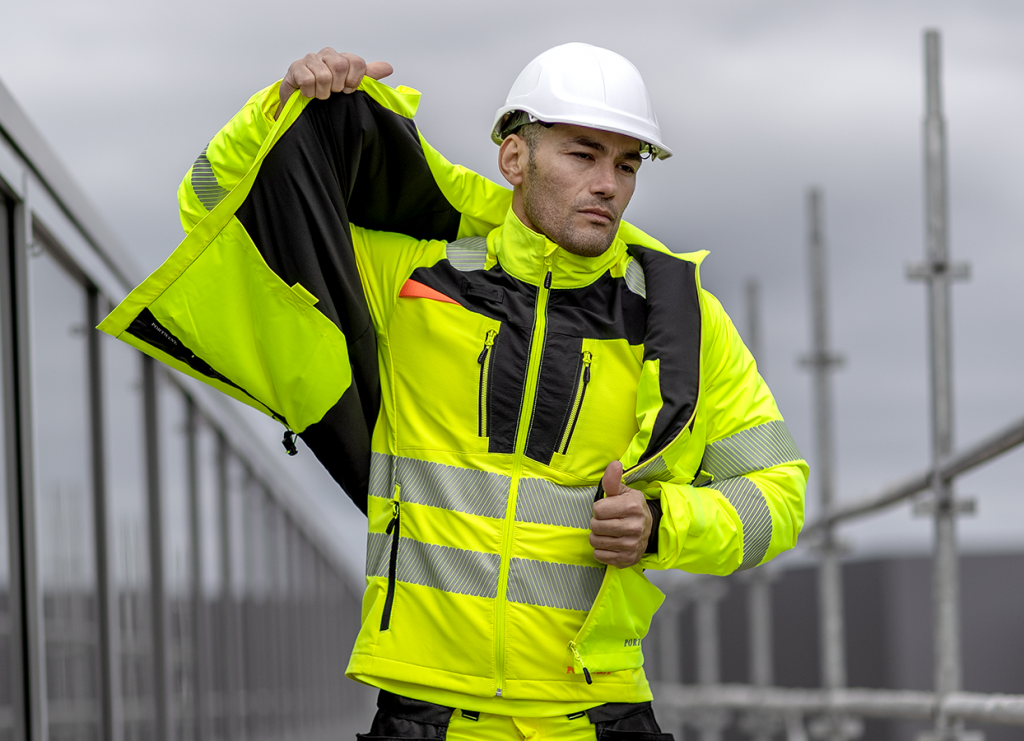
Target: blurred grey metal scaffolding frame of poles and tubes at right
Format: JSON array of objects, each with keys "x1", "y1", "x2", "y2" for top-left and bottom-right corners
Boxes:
[{"x1": 654, "y1": 30, "x2": 1024, "y2": 741}]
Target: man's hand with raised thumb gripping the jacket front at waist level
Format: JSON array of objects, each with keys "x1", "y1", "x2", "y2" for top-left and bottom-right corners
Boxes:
[{"x1": 590, "y1": 461, "x2": 653, "y2": 568}]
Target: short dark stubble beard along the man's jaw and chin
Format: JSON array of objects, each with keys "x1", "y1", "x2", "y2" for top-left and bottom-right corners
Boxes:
[{"x1": 522, "y1": 151, "x2": 618, "y2": 257}]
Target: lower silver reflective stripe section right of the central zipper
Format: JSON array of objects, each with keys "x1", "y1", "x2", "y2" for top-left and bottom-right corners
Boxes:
[{"x1": 508, "y1": 559, "x2": 606, "y2": 610}]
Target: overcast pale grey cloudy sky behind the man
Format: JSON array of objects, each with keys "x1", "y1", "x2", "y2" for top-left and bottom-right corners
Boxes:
[{"x1": 0, "y1": 0, "x2": 1024, "y2": 573}]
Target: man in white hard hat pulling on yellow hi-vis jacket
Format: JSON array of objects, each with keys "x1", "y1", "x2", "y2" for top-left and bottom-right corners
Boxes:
[{"x1": 102, "y1": 44, "x2": 807, "y2": 739}]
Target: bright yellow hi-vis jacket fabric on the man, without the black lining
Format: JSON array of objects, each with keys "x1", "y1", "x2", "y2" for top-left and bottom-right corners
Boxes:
[{"x1": 101, "y1": 80, "x2": 807, "y2": 716}]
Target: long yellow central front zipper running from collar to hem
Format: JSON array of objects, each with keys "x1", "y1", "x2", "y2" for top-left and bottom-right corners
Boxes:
[{"x1": 495, "y1": 268, "x2": 552, "y2": 697}]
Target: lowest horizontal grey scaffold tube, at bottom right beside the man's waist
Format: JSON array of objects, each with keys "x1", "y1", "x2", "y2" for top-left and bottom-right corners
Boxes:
[{"x1": 653, "y1": 684, "x2": 1024, "y2": 726}]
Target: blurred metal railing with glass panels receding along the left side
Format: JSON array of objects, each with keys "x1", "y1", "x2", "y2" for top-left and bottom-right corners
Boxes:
[{"x1": 0, "y1": 71, "x2": 373, "y2": 741}]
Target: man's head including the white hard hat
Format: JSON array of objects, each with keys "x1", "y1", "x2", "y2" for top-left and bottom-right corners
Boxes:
[{"x1": 492, "y1": 44, "x2": 672, "y2": 257}]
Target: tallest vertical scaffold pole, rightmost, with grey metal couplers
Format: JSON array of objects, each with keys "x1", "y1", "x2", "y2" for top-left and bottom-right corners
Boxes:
[{"x1": 907, "y1": 30, "x2": 969, "y2": 741}]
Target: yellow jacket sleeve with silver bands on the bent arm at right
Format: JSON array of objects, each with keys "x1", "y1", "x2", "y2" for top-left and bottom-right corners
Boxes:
[{"x1": 641, "y1": 292, "x2": 808, "y2": 575}]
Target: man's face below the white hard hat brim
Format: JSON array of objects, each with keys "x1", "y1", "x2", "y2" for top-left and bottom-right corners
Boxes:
[{"x1": 516, "y1": 124, "x2": 641, "y2": 257}]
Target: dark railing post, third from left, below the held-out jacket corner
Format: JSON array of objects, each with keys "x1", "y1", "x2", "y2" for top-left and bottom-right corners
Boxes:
[{"x1": 142, "y1": 357, "x2": 173, "y2": 741}]
